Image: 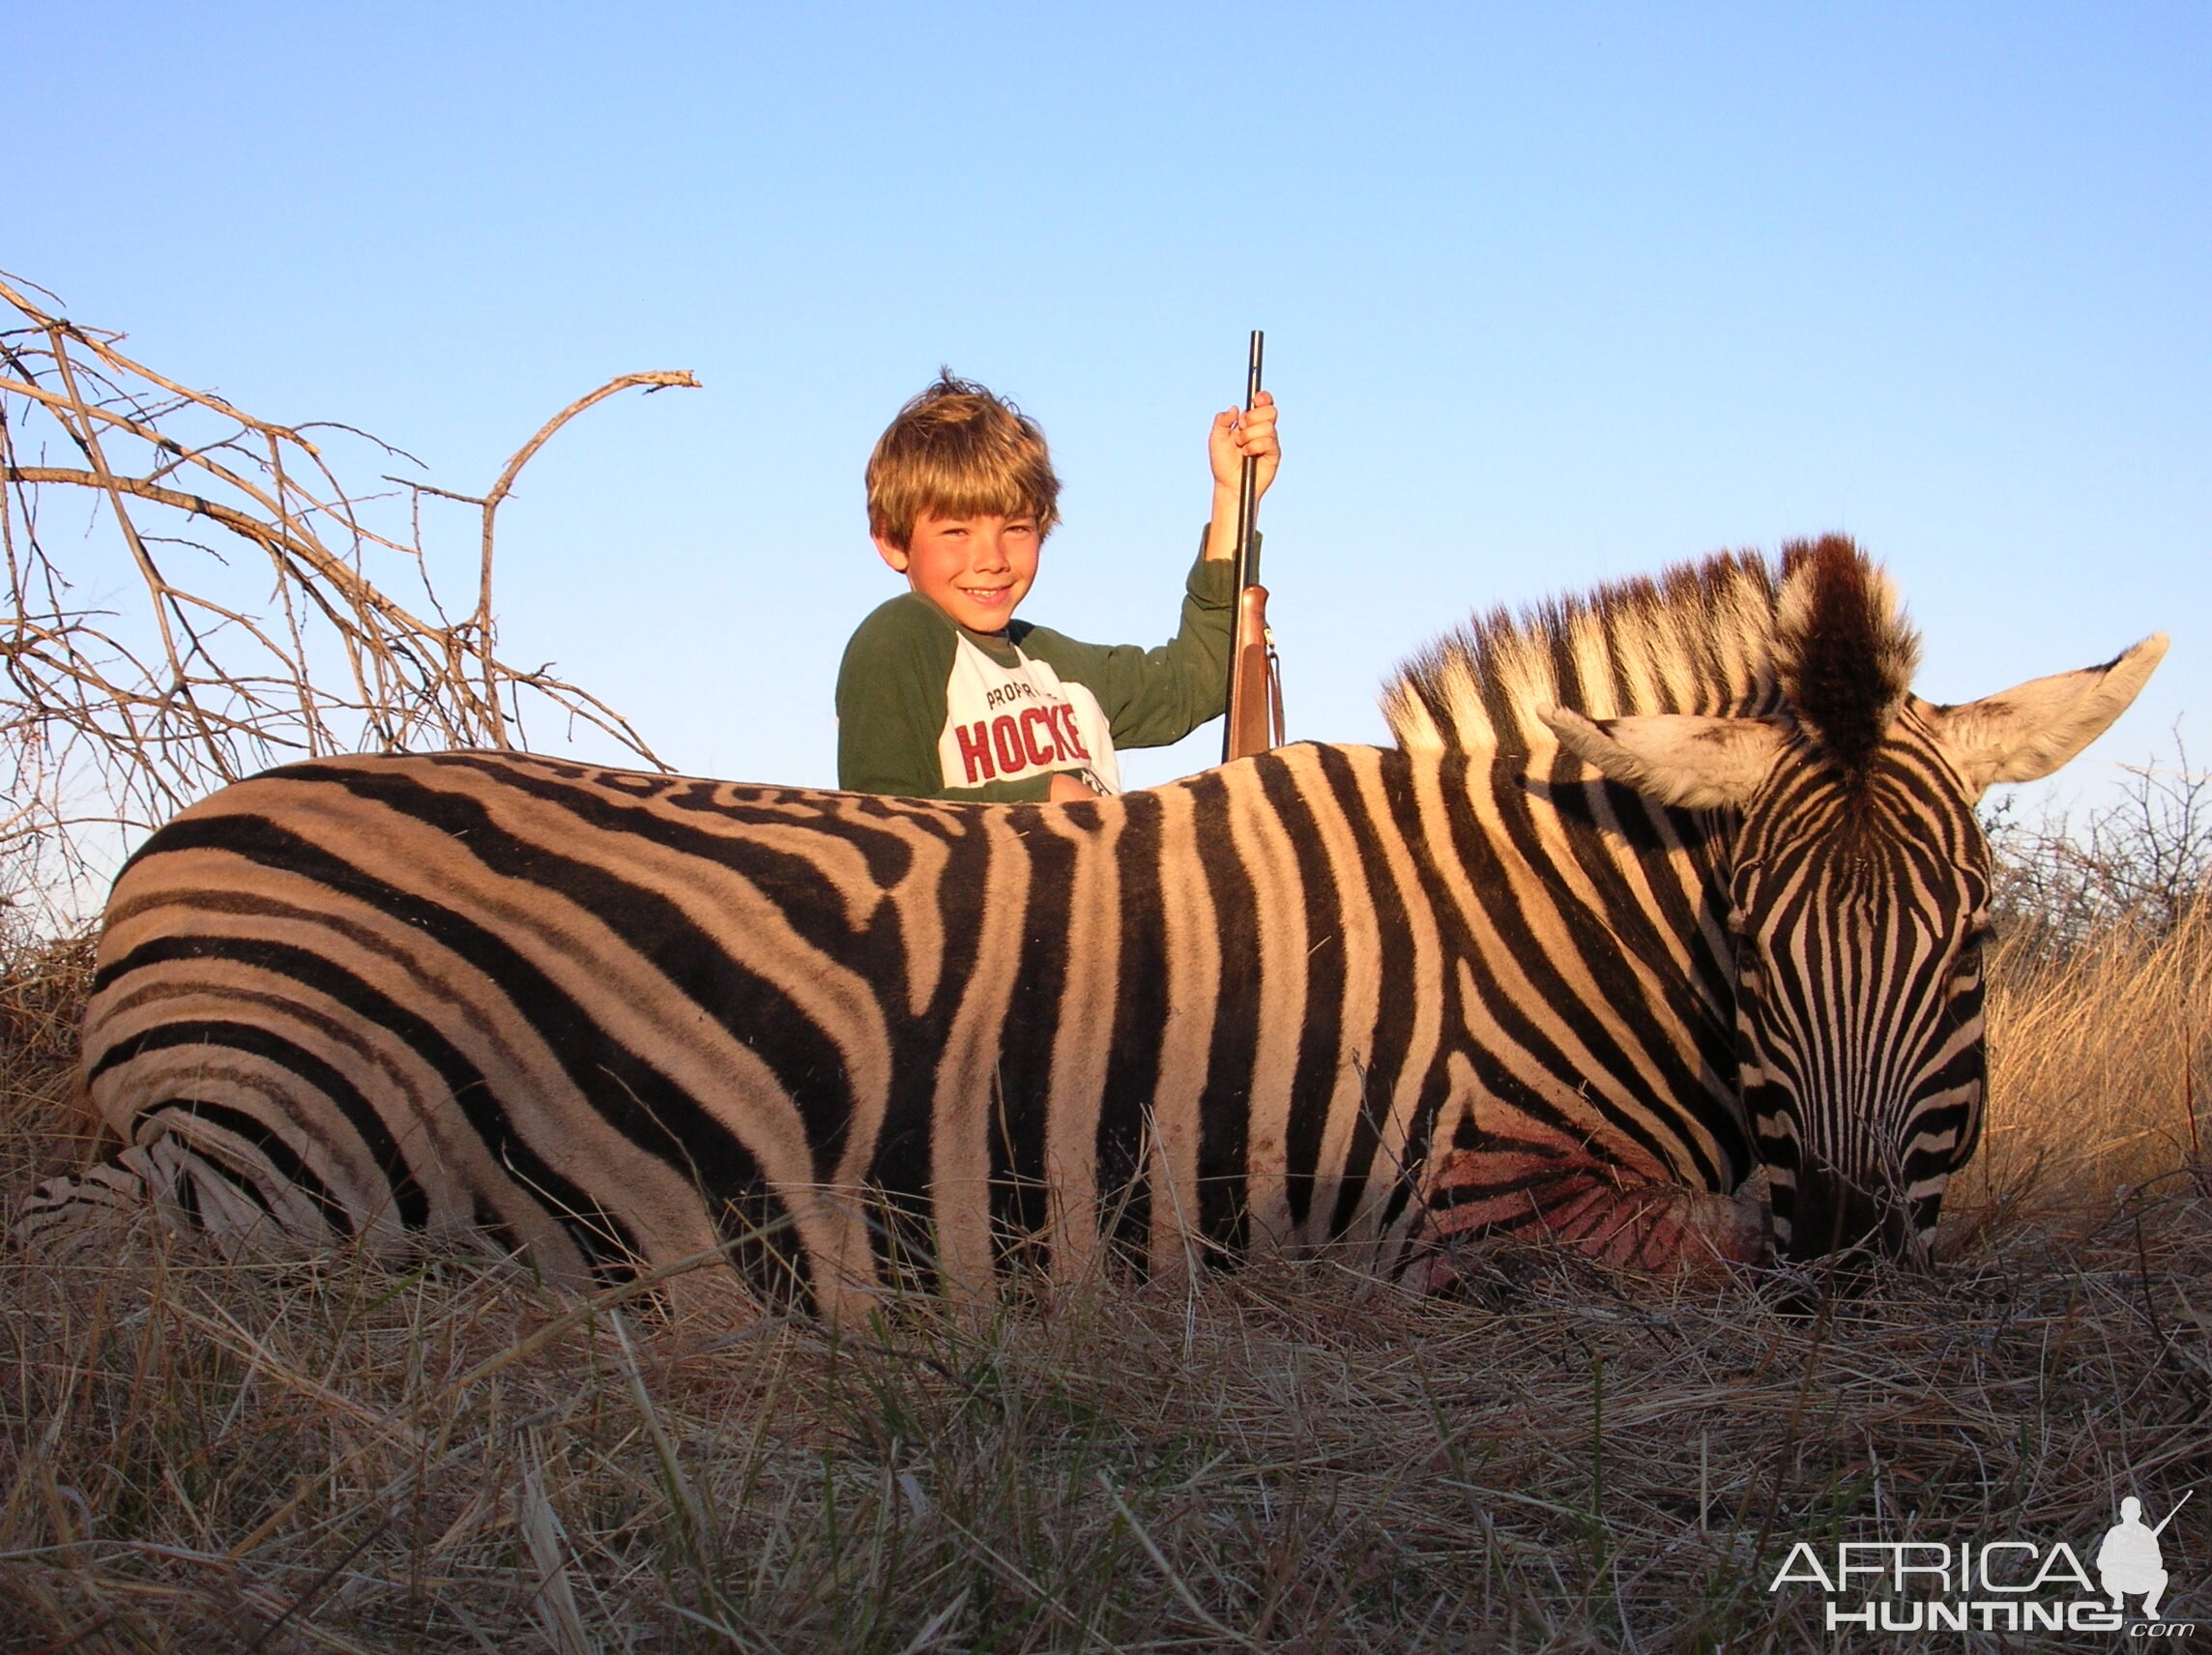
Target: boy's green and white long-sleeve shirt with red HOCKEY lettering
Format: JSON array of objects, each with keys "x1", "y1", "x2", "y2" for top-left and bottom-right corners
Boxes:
[{"x1": 836, "y1": 558, "x2": 1235, "y2": 801}]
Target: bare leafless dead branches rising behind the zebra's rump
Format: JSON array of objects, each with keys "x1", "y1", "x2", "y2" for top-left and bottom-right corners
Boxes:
[{"x1": 0, "y1": 278, "x2": 699, "y2": 911}]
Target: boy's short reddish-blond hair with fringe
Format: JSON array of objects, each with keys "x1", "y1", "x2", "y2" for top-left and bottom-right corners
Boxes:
[{"x1": 867, "y1": 367, "x2": 1060, "y2": 549}]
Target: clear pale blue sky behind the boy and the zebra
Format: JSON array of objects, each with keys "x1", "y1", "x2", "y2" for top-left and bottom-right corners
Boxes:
[{"x1": 16, "y1": 0, "x2": 2212, "y2": 809}]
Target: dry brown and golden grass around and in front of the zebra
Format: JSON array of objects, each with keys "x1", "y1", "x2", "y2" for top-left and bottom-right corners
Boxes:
[{"x1": 0, "y1": 911, "x2": 2212, "y2": 1655}]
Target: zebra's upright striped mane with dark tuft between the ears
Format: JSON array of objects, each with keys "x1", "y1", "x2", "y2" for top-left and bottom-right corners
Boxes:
[{"x1": 1382, "y1": 536, "x2": 1920, "y2": 772}]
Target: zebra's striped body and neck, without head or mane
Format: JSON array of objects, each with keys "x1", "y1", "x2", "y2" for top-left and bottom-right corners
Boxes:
[{"x1": 60, "y1": 745, "x2": 1750, "y2": 1299}]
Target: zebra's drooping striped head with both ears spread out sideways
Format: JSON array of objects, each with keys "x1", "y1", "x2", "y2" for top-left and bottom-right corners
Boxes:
[{"x1": 1542, "y1": 537, "x2": 2166, "y2": 1262}]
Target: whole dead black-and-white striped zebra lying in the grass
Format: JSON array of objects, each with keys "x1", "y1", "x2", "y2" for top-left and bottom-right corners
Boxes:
[{"x1": 20, "y1": 536, "x2": 2166, "y2": 1319}]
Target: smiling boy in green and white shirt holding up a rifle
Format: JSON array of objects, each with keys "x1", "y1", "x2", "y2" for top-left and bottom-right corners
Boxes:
[{"x1": 836, "y1": 372, "x2": 1281, "y2": 801}]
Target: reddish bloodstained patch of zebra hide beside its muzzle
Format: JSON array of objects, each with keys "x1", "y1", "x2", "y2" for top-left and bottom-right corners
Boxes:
[{"x1": 1407, "y1": 1118, "x2": 1772, "y2": 1292}]
